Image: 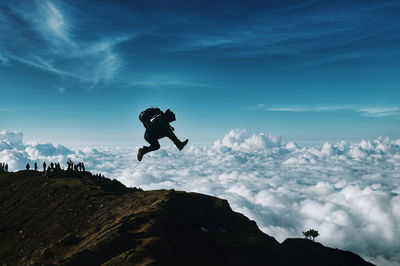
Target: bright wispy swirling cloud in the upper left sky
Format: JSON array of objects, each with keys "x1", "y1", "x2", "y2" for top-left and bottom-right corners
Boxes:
[{"x1": 0, "y1": 0, "x2": 129, "y2": 90}]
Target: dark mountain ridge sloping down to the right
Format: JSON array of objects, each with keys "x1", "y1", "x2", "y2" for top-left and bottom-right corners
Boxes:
[{"x1": 0, "y1": 171, "x2": 372, "y2": 266}]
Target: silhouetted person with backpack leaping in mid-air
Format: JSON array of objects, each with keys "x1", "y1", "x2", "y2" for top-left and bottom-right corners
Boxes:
[{"x1": 137, "y1": 108, "x2": 189, "y2": 162}]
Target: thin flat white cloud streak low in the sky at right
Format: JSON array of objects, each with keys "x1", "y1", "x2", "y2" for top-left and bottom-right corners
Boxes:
[{"x1": 254, "y1": 104, "x2": 400, "y2": 117}]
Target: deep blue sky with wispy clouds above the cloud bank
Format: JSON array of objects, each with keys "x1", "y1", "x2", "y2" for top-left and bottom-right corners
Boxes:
[{"x1": 0, "y1": 0, "x2": 400, "y2": 144}]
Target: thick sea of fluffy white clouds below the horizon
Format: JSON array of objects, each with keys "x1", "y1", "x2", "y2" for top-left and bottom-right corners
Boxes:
[{"x1": 0, "y1": 129, "x2": 400, "y2": 265}]
